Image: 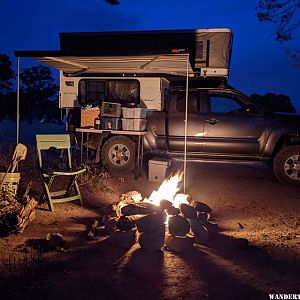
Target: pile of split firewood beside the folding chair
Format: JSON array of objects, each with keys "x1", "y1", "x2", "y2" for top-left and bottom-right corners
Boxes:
[{"x1": 0, "y1": 187, "x2": 38, "y2": 236}]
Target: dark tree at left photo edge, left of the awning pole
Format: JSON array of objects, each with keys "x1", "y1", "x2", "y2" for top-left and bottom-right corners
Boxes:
[{"x1": 0, "y1": 54, "x2": 15, "y2": 94}]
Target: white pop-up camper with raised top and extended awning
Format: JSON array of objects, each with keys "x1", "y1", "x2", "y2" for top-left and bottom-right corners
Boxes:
[{"x1": 15, "y1": 28, "x2": 232, "y2": 110}]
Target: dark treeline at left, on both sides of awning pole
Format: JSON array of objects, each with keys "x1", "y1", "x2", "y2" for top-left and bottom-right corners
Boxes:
[{"x1": 0, "y1": 54, "x2": 60, "y2": 122}]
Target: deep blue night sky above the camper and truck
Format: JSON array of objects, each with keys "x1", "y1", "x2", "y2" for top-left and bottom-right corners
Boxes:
[{"x1": 0, "y1": 0, "x2": 300, "y2": 112}]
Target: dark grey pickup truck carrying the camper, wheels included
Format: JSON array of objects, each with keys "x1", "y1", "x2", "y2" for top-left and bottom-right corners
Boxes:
[{"x1": 101, "y1": 81, "x2": 300, "y2": 185}]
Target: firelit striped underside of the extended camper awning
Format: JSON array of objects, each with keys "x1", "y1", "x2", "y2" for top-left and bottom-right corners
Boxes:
[{"x1": 16, "y1": 53, "x2": 193, "y2": 76}]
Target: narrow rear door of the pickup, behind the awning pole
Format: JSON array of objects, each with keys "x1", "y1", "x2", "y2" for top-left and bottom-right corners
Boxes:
[{"x1": 166, "y1": 91, "x2": 203, "y2": 153}]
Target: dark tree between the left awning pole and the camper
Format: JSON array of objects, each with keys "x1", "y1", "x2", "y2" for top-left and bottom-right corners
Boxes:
[{"x1": 20, "y1": 65, "x2": 58, "y2": 121}]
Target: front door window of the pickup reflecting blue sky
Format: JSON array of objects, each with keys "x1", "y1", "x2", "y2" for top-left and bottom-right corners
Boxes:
[{"x1": 210, "y1": 95, "x2": 243, "y2": 114}]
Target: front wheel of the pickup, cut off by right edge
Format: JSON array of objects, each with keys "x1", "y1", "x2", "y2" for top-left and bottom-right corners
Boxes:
[{"x1": 273, "y1": 146, "x2": 300, "y2": 185}]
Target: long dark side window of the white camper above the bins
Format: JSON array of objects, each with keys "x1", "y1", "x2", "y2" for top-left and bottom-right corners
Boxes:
[{"x1": 78, "y1": 79, "x2": 140, "y2": 106}]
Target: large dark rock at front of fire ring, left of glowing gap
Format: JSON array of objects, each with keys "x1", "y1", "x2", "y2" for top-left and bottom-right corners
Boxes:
[{"x1": 138, "y1": 224, "x2": 165, "y2": 251}]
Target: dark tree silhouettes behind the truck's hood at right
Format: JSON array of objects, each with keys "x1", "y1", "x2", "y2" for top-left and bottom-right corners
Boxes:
[{"x1": 250, "y1": 93, "x2": 296, "y2": 113}]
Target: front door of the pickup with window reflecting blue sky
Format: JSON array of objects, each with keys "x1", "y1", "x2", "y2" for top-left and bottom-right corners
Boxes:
[{"x1": 203, "y1": 92, "x2": 265, "y2": 157}]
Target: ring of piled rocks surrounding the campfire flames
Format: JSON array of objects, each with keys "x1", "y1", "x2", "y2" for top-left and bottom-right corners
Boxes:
[{"x1": 94, "y1": 191, "x2": 218, "y2": 252}]
